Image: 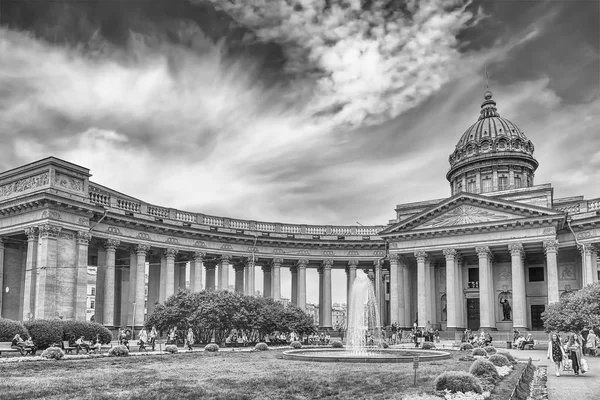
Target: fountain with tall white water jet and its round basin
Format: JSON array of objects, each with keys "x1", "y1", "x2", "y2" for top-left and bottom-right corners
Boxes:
[{"x1": 283, "y1": 270, "x2": 450, "y2": 363}]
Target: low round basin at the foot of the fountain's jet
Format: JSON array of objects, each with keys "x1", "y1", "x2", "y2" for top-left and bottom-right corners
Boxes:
[{"x1": 283, "y1": 348, "x2": 450, "y2": 363}]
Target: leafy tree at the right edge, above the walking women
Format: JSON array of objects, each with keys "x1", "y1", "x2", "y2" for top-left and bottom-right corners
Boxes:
[{"x1": 542, "y1": 282, "x2": 600, "y2": 332}]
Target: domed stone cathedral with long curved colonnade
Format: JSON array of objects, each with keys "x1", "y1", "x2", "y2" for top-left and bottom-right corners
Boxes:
[{"x1": 0, "y1": 91, "x2": 600, "y2": 331}]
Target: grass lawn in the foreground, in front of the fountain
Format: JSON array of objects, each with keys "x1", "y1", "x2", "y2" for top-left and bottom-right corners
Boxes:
[{"x1": 0, "y1": 350, "x2": 520, "y2": 400}]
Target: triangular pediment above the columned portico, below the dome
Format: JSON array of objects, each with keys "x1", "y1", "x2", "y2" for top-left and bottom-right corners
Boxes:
[{"x1": 380, "y1": 193, "x2": 563, "y2": 236}]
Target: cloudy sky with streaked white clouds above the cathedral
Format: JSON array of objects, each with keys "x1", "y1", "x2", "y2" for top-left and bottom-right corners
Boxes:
[{"x1": 0, "y1": 0, "x2": 600, "y2": 301}]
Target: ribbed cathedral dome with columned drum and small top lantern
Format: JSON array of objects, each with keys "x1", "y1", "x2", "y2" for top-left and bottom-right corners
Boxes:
[{"x1": 446, "y1": 90, "x2": 538, "y2": 194}]
